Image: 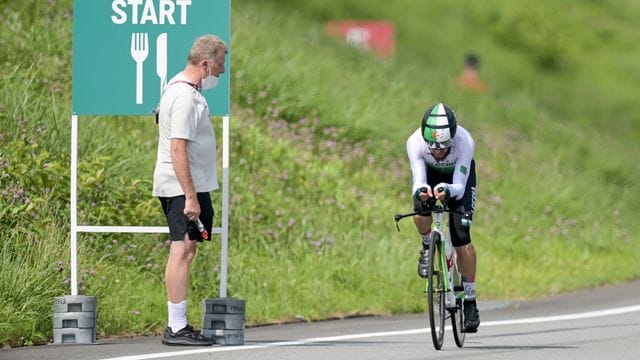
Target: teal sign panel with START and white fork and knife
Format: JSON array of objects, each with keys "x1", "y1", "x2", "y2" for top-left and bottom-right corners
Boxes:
[{"x1": 72, "y1": 0, "x2": 231, "y2": 115}]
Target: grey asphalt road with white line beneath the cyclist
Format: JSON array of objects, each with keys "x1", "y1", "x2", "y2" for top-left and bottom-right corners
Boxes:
[{"x1": 5, "y1": 280, "x2": 640, "y2": 360}]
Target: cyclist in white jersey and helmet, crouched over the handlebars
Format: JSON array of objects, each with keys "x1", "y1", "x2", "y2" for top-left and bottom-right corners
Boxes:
[{"x1": 407, "y1": 103, "x2": 480, "y2": 332}]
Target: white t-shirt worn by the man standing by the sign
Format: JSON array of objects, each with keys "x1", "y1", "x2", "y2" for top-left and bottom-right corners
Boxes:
[{"x1": 153, "y1": 73, "x2": 218, "y2": 197}]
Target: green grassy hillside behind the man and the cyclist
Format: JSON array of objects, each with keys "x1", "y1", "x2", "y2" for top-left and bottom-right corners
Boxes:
[{"x1": 0, "y1": 0, "x2": 640, "y2": 345}]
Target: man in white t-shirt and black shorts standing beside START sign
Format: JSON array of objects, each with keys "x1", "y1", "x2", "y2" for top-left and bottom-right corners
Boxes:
[{"x1": 153, "y1": 35, "x2": 227, "y2": 346}]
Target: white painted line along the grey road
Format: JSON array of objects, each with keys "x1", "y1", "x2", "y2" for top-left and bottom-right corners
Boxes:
[{"x1": 103, "y1": 305, "x2": 640, "y2": 360}]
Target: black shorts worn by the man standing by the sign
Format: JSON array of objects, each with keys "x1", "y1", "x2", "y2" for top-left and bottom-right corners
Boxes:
[{"x1": 159, "y1": 193, "x2": 213, "y2": 242}]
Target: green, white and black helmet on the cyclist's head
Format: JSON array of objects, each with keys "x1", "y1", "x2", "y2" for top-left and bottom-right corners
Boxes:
[{"x1": 422, "y1": 103, "x2": 458, "y2": 149}]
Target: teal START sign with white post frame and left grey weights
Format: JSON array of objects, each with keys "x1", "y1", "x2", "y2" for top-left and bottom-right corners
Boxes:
[{"x1": 59, "y1": 0, "x2": 231, "y2": 343}]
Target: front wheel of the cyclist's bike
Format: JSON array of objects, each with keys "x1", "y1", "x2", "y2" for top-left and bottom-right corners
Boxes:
[{"x1": 427, "y1": 232, "x2": 446, "y2": 350}]
